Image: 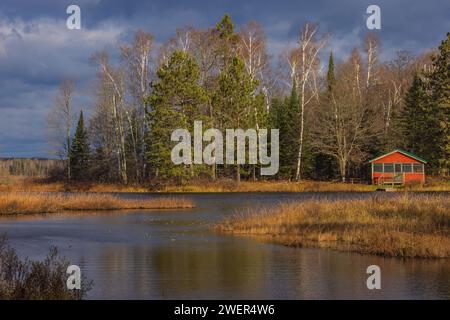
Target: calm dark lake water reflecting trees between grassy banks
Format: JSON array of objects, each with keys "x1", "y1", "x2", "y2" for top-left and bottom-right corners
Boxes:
[{"x1": 0, "y1": 193, "x2": 450, "y2": 299}]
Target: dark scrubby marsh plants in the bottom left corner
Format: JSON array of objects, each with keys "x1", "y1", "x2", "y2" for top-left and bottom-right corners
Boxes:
[{"x1": 0, "y1": 237, "x2": 93, "y2": 300}]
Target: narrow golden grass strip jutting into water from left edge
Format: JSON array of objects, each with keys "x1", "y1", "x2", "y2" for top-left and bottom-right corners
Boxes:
[{"x1": 0, "y1": 192, "x2": 194, "y2": 215}]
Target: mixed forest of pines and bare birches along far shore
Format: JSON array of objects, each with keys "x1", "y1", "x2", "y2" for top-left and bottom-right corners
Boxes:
[{"x1": 44, "y1": 14, "x2": 450, "y2": 184}]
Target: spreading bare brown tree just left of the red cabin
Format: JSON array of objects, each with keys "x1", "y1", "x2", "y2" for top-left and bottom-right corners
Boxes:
[{"x1": 312, "y1": 50, "x2": 380, "y2": 182}]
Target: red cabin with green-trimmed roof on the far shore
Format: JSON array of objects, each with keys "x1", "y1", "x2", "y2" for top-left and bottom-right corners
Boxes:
[{"x1": 370, "y1": 149, "x2": 427, "y2": 185}]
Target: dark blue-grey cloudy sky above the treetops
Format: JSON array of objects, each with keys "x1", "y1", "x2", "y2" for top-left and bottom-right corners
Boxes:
[{"x1": 0, "y1": 0, "x2": 450, "y2": 157}]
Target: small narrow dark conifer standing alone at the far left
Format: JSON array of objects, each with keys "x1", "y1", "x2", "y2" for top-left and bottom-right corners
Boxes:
[{"x1": 70, "y1": 111, "x2": 90, "y2": 181}]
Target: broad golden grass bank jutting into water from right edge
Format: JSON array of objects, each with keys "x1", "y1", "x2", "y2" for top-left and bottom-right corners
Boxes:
[{"x1": 216, "y1": 194, "x2": 450, "y2": 258}]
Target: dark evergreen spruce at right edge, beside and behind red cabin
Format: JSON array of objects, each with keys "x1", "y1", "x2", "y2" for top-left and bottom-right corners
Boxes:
[{"x1": 397, "y1": 33, "x2": 450, "y2": 175}]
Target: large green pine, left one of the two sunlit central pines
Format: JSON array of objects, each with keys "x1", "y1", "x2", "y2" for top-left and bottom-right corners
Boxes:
[{"x1": 146, "y1": 51, "x2": 206, "y2": 178}]
